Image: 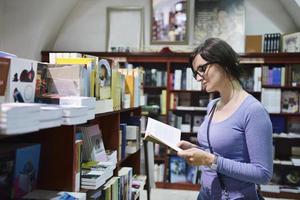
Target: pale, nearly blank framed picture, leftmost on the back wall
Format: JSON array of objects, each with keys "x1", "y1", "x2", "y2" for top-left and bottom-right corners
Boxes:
[{"x1": 106, "y1": 7, "x2": 144, "y2": 52}]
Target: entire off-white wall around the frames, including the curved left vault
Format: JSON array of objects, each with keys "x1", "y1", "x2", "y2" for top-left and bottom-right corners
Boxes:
[{"x1": 0, "y1": 0, "x2": 297, "y2": 60}]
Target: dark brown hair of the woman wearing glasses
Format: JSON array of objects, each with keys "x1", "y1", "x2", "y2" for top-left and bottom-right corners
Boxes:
[{"x1": 189, "y1": 38, "x2": 242, "y2": 83}]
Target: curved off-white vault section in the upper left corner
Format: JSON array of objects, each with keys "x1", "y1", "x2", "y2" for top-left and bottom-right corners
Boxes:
[{"x1": 1, "y1": 0, "x2": 78, "y2": 60}]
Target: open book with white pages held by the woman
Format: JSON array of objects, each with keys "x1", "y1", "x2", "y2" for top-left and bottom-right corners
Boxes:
[{"x1": 144, "y1": 117, "x2": 181, "y2": 151}]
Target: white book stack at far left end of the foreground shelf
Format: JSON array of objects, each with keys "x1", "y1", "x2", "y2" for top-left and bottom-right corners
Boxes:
[{"x1": 0, "y1": 103, "x2": 40, "y2": 135}]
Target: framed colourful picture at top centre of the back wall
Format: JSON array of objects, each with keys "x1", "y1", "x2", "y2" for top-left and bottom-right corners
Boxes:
[{"x1": 150, "y1": 0, "x2": 189, "y2": 44}]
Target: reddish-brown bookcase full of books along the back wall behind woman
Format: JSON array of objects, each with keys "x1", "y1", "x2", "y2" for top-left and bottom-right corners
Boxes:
[{"x1": 42, "y1": 51, "x2": 300, "y2": 199}]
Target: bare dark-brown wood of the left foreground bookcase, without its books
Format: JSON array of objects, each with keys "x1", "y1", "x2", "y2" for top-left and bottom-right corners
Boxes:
[{"x1": 0, "y1": 107, "x2": 141, "y2": 192}]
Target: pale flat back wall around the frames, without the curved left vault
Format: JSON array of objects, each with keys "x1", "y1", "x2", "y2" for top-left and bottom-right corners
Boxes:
[{"x1": 54, "y1": 0, "x2": 297, "y2": 51}]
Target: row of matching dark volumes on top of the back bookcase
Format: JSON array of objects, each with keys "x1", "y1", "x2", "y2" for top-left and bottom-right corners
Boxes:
[{"x1": 263, "y1": 33, "x2": 281, "y2": 53}]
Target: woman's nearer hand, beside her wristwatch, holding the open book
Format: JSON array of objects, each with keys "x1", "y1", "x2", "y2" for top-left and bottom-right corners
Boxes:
[{"x1": 177, "y1": 148, "x2": 215, "y2": 166}]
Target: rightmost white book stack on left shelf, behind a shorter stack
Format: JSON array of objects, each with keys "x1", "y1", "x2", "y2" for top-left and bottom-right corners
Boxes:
[{"x1": 59, "y1": 96, "x2": 96, "y2": 120}]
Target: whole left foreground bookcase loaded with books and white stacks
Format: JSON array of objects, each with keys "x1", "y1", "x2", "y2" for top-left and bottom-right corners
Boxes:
[{"x1": 0, "y1": 54, "x2": 145, "y2": 200}]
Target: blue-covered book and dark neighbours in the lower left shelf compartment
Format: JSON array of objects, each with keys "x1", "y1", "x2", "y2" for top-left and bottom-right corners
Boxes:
[{"x1": 0, "y1": 143, "x2": 41, "y2": 199}]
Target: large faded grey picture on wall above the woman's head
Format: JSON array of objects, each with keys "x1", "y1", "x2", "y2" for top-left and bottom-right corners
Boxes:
[{"x1": 193, "y1": 0, "x2": 245, "y2": 53}]
